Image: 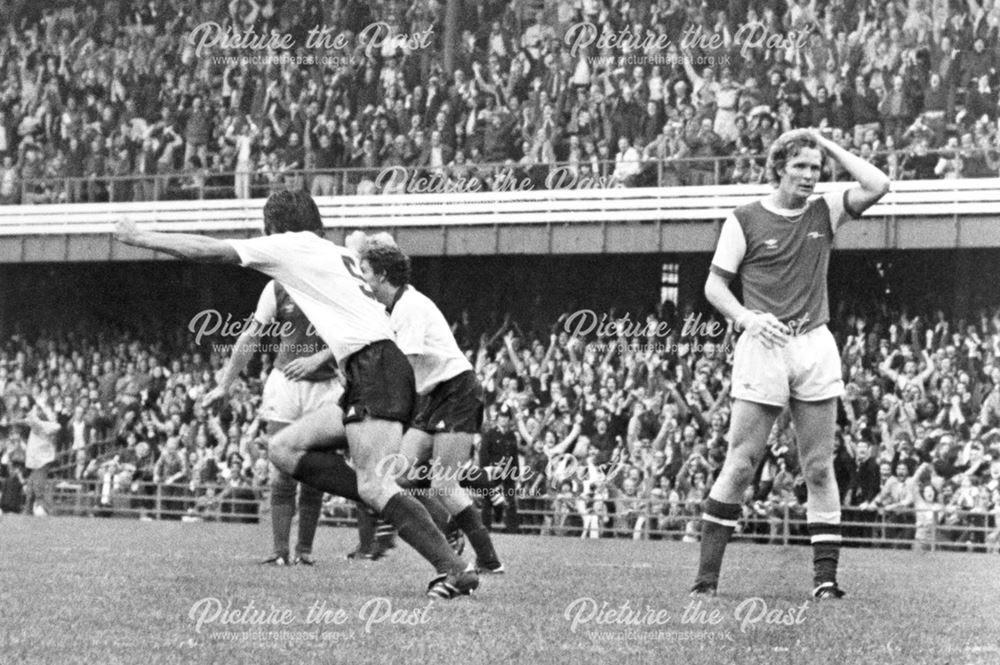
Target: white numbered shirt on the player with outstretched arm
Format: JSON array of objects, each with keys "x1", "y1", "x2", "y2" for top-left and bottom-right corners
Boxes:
[{"x1": 228, "y1": 231, "x2": 392, "y2": 367}]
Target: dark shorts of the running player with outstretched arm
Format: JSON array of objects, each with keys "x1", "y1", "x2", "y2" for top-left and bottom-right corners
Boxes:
[{"x1": 340, "y1": 339, "x2": 417, "y2": 425}]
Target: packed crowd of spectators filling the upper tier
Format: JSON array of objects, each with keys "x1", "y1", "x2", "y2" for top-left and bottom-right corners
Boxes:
[{"x1": 0, "y1": 0, "x2": 1000, "y2": 203}]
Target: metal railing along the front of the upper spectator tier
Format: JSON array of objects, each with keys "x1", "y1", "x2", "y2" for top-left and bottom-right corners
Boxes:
[{"x1": 0, "y1": 149, "x2": 1000, "y2": 205}]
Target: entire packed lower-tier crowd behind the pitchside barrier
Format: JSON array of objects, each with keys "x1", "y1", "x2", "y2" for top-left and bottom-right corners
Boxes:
[{"x1": 0, "y1": 306, "x2": 1000, "y2": 548}]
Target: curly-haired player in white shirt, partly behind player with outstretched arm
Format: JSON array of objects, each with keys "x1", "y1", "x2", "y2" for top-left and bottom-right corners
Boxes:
[{"x1": 361, "y1": 236, "x2": 504, "y2": 573}]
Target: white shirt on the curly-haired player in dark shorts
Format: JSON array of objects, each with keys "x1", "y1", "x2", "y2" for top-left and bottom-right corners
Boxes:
[{"x1": 389, "y1": 285, "x2": 472, "y2": 395}]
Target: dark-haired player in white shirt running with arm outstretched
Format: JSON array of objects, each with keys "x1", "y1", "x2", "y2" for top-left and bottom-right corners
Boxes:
[{"x1": 115, "y1": 191, "x2": 479, "y2": 598}]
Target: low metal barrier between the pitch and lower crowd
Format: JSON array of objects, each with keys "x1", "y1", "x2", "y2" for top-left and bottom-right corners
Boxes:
[{"x1": 11, "y1": 478, "x2": 1000, "y2": 553}]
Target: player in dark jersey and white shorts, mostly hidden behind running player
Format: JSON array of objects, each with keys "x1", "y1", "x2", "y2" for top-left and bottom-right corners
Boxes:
[{"x1": 203, "y1": 280, "x2": 343, "y2": 566}]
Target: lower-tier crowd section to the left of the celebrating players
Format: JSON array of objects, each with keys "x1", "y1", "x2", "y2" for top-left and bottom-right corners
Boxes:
[{"x1": 0, "y1": 328, "x2": 268, "y2": 518}]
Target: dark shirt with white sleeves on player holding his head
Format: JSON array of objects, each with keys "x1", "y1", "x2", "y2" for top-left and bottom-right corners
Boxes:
[{"x1": 711, "y1": 191, "x2": 856, "y2": 333}]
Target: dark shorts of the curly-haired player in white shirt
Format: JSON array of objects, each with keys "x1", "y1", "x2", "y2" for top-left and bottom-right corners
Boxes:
[{"x1": 410, "y1": 370, "x2": 483, "y2": 434}]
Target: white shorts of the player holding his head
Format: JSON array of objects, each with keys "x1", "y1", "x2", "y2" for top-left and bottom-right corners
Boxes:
[{"x1": 732, "y1": 326, "x2": 844, "y2": 406}]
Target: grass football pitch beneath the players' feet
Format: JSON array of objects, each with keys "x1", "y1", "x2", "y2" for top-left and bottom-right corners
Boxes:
[{"x1": 0, "y1": 515, "x2": 1000, "y2": 665}]
